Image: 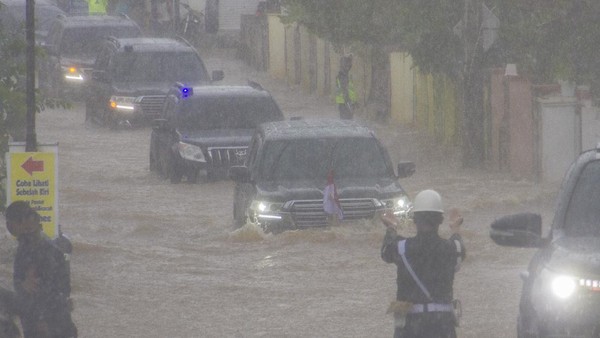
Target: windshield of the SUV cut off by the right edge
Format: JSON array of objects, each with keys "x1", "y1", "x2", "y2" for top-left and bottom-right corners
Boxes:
[{"x1": 565, "y1": 161, "x2": 600, "y2": 237}]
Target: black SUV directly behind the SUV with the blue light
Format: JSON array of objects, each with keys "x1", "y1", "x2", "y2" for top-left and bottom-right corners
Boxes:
[{"x1": 85, "y1": 38, "x2": 223, "y2": 127}]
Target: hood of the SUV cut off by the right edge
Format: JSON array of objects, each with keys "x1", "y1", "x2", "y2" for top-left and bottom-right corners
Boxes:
[{"x1": 548, "y1": 237, "x2": 600, "y2": 276}]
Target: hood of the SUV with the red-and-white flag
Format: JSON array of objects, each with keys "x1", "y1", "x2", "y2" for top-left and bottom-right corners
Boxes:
[{"x1": 256, "y1": 178, "x2": 406, "y2": 202}]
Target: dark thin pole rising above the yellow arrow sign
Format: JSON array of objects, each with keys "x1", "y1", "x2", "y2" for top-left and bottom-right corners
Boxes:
[{"x1": 25, "y1": 0, "x2": 37, "y2": 152}]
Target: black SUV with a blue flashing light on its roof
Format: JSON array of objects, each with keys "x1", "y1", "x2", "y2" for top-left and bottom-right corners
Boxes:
[{"x1": 150, "y1": 83, "x2": 283, "y2": 183}]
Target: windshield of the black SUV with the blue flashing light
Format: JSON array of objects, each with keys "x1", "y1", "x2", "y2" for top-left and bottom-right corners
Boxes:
[{"x1": 177, "y1": 96, "x2": 283, "y2": 130}]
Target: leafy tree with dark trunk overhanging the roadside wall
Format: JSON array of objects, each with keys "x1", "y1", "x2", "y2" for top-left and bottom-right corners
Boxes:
[{"x1": 283, "y1": 0, "x2": 600, "y2": 167}]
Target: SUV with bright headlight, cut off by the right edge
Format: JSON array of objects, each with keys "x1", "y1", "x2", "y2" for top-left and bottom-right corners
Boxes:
[{"x1": 490, "y1": 146, "x2": 600, "y2": 337}]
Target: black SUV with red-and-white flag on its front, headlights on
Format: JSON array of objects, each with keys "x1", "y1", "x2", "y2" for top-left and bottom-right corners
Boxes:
[{"x1": 229, "y1": 119, "x2": 415, "y2": 232}]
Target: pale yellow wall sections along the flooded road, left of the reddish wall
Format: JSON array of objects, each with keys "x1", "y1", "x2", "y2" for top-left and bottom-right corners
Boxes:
[{"x1": 268, "y1": 15, "x2": 459, "y2": 144}]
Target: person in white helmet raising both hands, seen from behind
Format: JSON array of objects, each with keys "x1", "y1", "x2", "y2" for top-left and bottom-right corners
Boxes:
[{"x1": 381, "y1": 190, "x2": 465, "y2": 338}]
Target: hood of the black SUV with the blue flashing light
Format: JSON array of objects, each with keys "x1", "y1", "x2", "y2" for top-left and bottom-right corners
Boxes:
[{"x1": 178, "y1": 129, "x2": 254, "y2": 147}]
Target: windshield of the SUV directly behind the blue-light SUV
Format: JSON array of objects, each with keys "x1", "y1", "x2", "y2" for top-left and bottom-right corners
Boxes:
[{"x1": 111, "y1": 51, "x2": 208, "y2": 82}]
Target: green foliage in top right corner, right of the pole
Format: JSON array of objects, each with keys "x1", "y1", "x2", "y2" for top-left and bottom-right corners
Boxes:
[{"x1": 501, "y1": 0, "x2": 600, "y2": 90}]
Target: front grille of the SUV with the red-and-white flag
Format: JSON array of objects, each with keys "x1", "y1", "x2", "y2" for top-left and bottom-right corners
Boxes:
[{"x1": 284, "y1": 198, "x2": 376, "y2": 227}]
